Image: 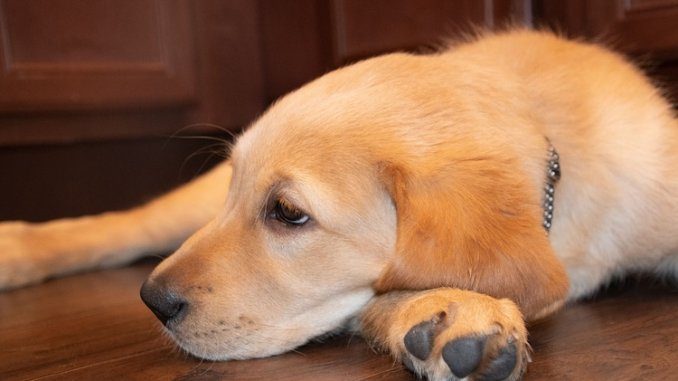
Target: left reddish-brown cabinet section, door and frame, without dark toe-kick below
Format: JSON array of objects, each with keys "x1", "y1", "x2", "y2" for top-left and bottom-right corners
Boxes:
[{"x1": 0, "y1": 0, "x2": 263, "y2": 145}]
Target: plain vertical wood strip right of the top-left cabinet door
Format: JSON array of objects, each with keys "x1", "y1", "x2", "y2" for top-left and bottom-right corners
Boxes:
[{"x1": 189, "y1": 0, "x2": 264, "y2": 132}]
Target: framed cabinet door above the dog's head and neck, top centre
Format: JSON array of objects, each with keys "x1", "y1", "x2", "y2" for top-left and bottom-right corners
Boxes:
[{"x1": 259, "y1": 0, "x2": 532, "y2": 102}]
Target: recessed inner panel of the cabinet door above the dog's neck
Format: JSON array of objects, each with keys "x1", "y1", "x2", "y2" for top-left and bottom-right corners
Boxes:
[{"x1": 331, "y1": 0, "x2": 529, "y2": 63}]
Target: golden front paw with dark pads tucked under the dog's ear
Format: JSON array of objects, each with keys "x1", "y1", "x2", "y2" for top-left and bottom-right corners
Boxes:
[{"x1": 359, "y1": 288, "x2": 529, "y2": 381}]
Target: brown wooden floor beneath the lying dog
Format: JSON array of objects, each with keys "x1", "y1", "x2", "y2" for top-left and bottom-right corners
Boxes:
[{"x1": 0, "y1": 261, "x2": 678, "y2": 381}]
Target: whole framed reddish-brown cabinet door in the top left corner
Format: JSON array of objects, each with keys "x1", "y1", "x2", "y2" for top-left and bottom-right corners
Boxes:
[{"x1": 0, "y1": 0, "x2": 195, "y2": 112}]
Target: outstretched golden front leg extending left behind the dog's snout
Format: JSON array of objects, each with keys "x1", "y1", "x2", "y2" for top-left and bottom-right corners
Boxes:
[{"x1": 0, "y1": 162, "x2": 231, "y2": 290}]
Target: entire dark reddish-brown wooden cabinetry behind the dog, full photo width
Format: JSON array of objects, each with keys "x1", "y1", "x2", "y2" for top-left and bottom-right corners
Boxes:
[{"x1": 0, "y1": 0, "x2": 678, "y2": 220}]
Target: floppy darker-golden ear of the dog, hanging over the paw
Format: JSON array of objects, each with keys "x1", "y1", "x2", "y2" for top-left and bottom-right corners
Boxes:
[{"x1": 374, "y1": 152, "x2": 568, "y2": 317}]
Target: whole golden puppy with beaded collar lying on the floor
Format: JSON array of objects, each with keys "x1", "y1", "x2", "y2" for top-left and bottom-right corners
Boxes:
[{"x1": 0, "y1": 30, "x2": 678, "y2": 380}]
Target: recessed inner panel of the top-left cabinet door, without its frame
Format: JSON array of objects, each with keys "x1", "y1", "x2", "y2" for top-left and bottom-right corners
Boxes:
[{"x1": 1, "y1": 0, "x2": 163, "y2": 64}]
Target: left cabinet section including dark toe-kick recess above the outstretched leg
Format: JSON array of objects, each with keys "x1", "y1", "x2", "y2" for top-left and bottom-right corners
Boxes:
[{"x1": 0, "y1": 0, "x2": 264, "y2": 220}]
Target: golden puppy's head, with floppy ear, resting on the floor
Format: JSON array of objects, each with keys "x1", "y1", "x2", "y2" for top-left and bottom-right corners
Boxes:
[{"x1": 142, "y1": 54, "x2": 566, "y2": 359}]
